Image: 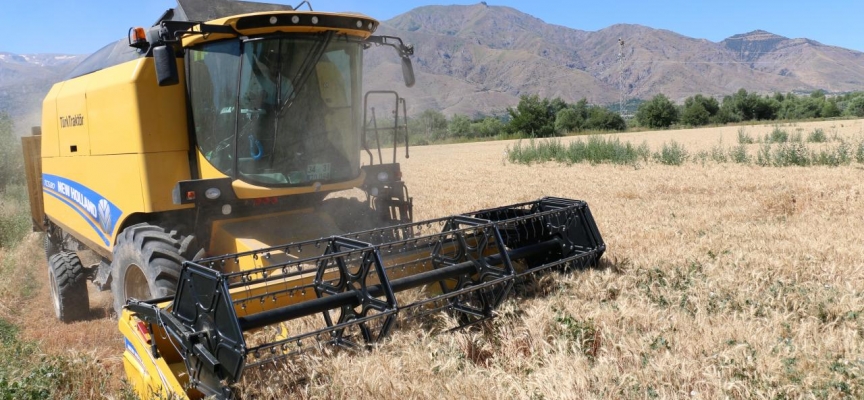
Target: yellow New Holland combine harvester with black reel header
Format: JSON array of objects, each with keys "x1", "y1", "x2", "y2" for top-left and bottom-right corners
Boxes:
[{"x1": 18, "y1": 0, "x2": 605, "y2": 398}]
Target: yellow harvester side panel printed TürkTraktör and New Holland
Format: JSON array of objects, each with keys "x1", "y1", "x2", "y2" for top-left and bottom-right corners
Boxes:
[{"x1": 41, "y1": 58, "x2": 192, "y2": 255}]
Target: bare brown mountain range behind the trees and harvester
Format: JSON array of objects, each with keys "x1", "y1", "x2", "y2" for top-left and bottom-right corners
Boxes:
[{"x1": 0, "y1": 2, "x2": 864, "y2": 132}]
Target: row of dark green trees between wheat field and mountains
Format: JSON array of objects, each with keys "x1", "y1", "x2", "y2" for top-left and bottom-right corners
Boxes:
[{"x1": 408, "y1": 89, "x2": 864, "y2": 144}]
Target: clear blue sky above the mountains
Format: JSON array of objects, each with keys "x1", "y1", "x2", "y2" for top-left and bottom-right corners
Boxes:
[{"x1": 0, "y1": 0, "x2": 864, "y2": 54}]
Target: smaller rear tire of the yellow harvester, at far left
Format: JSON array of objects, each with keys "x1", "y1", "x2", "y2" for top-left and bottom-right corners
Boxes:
[{"x1": 48, "y1": 251, "x2": 90, "y2": 322}]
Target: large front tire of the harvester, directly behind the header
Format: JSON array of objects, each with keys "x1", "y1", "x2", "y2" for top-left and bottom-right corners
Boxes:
[{"x1": 111, "y1": 223, "x2": 199, "y2": 315}]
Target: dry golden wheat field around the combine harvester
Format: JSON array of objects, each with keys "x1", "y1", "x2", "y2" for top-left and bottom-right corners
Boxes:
[{"x1": 0, "y1": 120, "x2": 864, "y2": 399}]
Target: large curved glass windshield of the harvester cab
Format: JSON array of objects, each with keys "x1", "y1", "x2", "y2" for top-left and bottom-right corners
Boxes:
[{"x1": 188, "y1": 33, "x2": 362, "y2": 186}]
